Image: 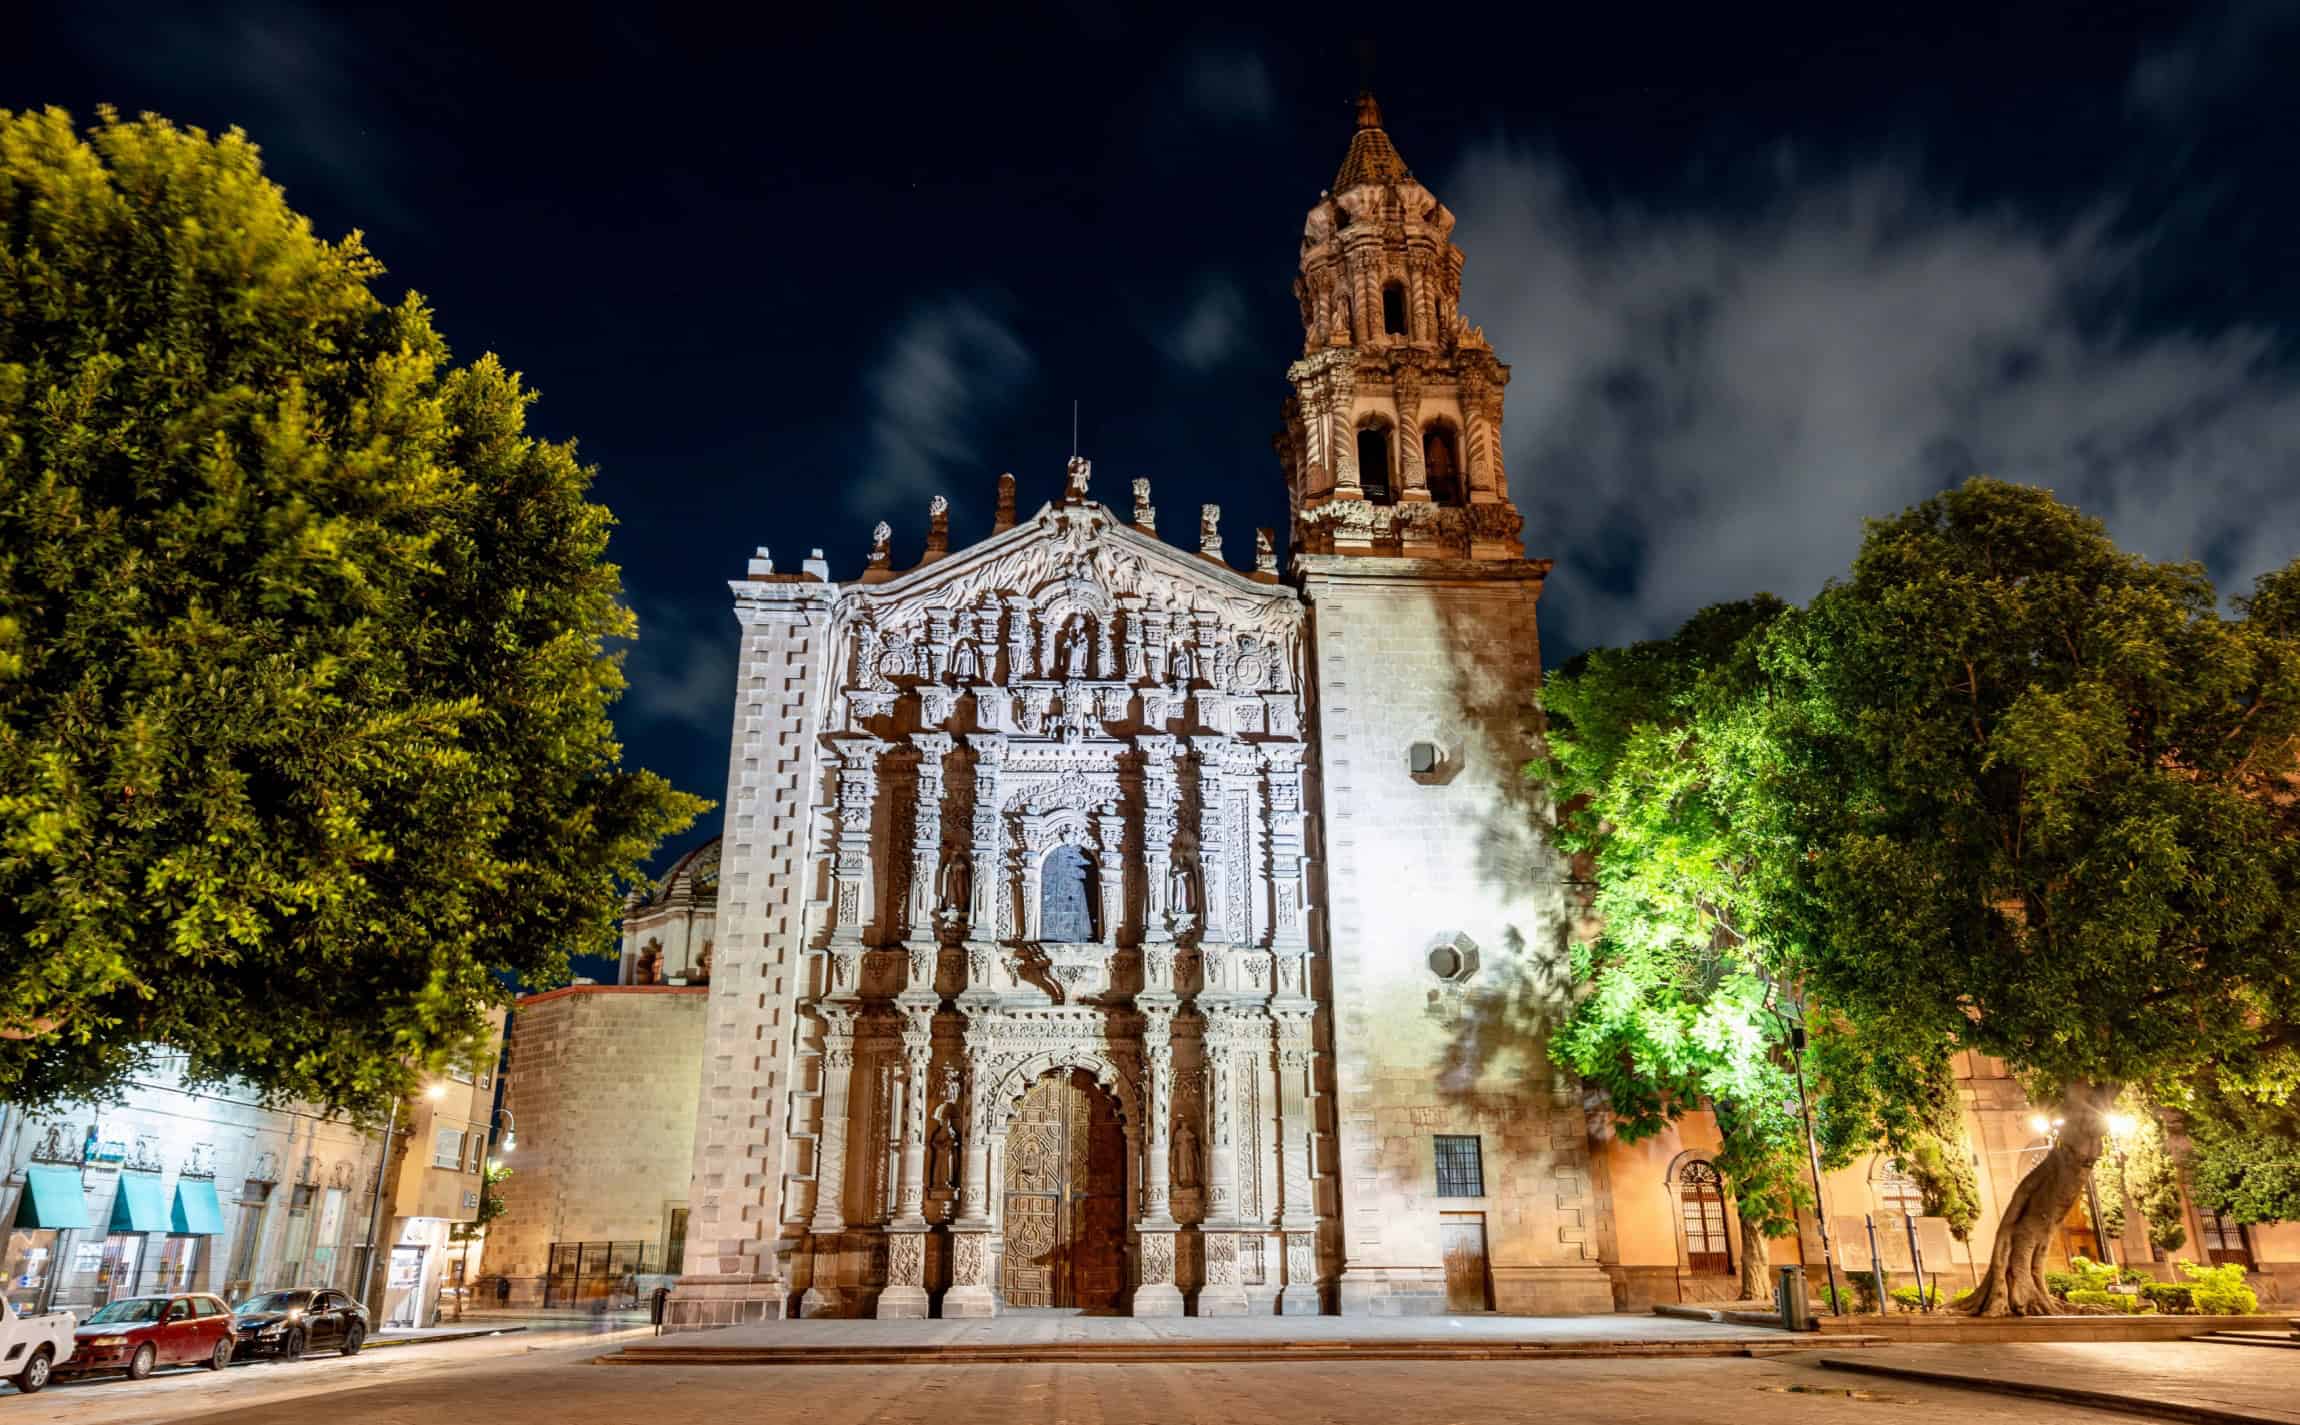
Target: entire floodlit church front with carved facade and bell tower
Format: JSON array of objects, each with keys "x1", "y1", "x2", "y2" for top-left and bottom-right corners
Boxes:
[{"x1": 669, "y1": 99, "x2": 1612, "y2": 1328}]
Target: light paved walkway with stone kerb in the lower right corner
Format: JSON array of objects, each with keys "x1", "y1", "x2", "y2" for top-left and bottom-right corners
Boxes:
[{"x1": 1819, "y1": 1340, "x2": 2300, "y2": 1425}]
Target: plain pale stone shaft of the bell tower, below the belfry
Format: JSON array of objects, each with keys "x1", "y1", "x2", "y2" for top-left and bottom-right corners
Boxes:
[{"x1": 1297, "y1": 556, "x2": 1612, "y2": 1312}]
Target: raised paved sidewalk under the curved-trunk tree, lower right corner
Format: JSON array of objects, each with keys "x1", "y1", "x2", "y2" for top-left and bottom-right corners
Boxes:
[{"x1": 1826, "y1": 1322, "x2": 2300, "y2": 1425}]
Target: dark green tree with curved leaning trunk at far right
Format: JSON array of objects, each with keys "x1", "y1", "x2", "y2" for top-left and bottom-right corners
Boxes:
[{"x1": 1750, "y1": 480, "x2": 2300, "y2": 1315}]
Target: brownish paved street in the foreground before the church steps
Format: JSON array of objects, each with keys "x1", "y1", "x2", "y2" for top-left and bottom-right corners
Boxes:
[{"x1": 147, "y1": 1351, "x2": 2130, "y2": 1425}]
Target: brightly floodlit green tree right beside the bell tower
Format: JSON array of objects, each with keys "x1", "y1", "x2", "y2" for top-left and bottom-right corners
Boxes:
[{"x1": 1534, "y1": 598, "x2": 1971, "y2": 1296}]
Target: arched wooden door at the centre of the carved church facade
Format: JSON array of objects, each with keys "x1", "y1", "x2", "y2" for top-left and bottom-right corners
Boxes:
[{"x1": 1001, "y1": 1069, "x2": 1127, "y2": 1310}]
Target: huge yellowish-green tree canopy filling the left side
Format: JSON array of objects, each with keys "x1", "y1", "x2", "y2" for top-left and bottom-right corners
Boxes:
[{"x1": 0, "y1": 110, "x2": 702, "y2": 1106}]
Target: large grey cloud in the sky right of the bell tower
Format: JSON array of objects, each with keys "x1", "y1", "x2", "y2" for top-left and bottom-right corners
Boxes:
[{"x1": 1447, "y1": 145, "x2": 2300, "y2": 646}]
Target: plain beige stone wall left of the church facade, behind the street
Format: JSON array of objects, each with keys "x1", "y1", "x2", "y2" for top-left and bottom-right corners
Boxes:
[{"x1": 485, "y1": 984, "x2": 706, "y2": 1303}]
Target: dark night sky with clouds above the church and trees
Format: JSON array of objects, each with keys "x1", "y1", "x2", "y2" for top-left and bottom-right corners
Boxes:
[{"x1": 0, "y1": 2, "x2": 2300, "y2": 969}]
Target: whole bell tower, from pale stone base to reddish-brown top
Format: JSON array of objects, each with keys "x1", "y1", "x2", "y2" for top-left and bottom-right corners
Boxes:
[{"x1": 1279, "y1": 97, "x2": 1612, "y2": 1315}]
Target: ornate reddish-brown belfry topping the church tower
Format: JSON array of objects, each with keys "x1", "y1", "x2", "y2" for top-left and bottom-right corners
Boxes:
[{"x1": 1277, "y1": 94, "x2": 1525, "y2": 561}]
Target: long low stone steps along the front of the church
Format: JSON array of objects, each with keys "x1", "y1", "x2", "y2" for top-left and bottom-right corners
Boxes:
[{"x1": 593, "y1": 1333, "x2": 1870, "y2": 1365}]
